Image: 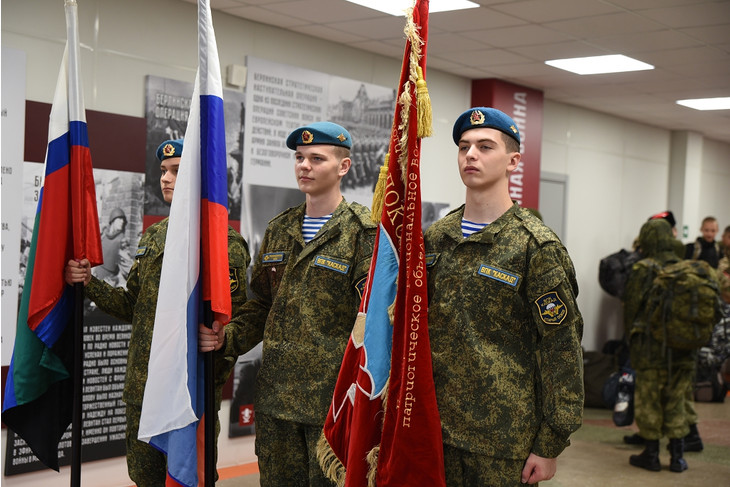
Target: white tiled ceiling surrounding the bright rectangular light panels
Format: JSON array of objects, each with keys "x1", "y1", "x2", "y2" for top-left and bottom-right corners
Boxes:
[{"x1": 189, "y1": 0, "x2": 730, "y2": 144}]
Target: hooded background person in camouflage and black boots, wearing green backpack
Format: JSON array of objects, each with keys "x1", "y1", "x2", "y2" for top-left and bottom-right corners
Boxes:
[{"x1": 624, "y1": 218, "x2": 718, "y2": 472}]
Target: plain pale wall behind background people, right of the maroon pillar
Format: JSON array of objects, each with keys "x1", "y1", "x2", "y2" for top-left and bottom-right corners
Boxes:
[{"x1": 542, "y1": 100, "x2": 730, "y2": 350}]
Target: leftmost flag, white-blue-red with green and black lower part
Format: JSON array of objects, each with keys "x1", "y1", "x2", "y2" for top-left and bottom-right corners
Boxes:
[{"x1": 2, "y1": 2, "x2": 103, "y2": 470}]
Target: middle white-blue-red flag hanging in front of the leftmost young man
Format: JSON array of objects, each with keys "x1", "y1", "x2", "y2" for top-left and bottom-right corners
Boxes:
[{"x1": 138, "y1": 0, "x2": 231, "y2": 486}]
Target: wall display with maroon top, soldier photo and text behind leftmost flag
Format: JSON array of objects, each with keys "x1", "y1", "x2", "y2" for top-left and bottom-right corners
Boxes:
[{"x1": 2, "y1": 101, "x2": 145, "y2": 475}]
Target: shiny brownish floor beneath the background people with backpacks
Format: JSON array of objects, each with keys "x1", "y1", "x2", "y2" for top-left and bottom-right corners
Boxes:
[{"x1": 216, "y1": 398, "x2": 730, "y2": 487}]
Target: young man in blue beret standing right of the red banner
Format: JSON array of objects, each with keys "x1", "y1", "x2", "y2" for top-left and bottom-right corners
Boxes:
[{"x1": 425, "y1": 107, "x2": 584, "y2": 487}]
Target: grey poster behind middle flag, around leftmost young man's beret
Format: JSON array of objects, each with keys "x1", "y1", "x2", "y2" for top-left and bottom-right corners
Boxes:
[{"x1": 144, "y1": 75, "x2": 245, "y2": 220}]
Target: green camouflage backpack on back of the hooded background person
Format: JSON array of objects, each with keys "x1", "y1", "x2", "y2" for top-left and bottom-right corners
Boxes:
[{"x1": 644, "y1": 260, "x2": 721, "y2": 350}]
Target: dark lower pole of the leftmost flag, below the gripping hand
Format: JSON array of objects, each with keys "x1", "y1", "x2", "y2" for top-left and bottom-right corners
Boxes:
[{"x1": 71, "y1": 282, "x2": 84, "y2": 487}]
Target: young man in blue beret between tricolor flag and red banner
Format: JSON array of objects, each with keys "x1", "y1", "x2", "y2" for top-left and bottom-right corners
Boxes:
[{"x1": 200, "y1": 122, "x2": 376, "y2": 487}]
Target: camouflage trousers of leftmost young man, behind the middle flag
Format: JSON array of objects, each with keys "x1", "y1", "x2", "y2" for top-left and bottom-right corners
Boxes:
[{"x1": 126, "y1": 404, "x2": 220, "y2": 487}]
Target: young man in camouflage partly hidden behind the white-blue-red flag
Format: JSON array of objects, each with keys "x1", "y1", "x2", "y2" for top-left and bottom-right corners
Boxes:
[{"x1": 65, "y1": 139, "x2": 251, "y2": 487}]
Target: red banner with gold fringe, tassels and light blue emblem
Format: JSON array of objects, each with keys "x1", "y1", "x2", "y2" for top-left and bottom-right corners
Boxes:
[{"x1": 319, "y1": 0, "x2": 445, "y2": 487}]
